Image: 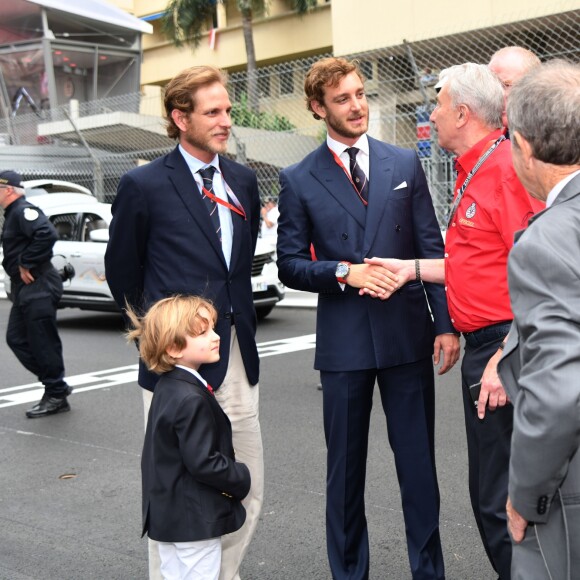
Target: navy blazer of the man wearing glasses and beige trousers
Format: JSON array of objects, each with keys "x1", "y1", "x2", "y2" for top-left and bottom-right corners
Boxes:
[{"x1": 105, "y1": 148, "x2": 260, "y2": 390}]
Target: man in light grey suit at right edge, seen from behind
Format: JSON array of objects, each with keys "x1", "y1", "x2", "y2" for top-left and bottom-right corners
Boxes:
[{"x1": 499, "y1": 61, "x2": 580, "y2": 580}]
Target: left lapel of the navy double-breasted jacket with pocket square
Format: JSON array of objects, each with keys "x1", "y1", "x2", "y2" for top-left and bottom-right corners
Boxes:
[{"x1": 310, "y1": 143, "x2": 366, "y2": 228}]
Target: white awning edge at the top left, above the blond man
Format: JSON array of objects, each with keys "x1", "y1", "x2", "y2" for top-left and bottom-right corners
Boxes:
[{"x1": 26, "y1": 0, "x2": 153, "y2": 34}]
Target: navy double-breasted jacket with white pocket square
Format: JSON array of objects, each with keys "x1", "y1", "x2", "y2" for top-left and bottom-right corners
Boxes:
[{"x1": 278, "y1": 137, "x2": 455, "y2": 371}]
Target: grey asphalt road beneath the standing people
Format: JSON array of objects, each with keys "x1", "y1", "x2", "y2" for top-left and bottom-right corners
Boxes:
[{"x1": 0, "y1": 300, "x2": 495, "y2": 580}]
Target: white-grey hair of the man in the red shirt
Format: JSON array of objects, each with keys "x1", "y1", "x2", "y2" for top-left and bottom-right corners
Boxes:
[{"x1": 439, "y1": 62, "x2": 504, "y2": 129}]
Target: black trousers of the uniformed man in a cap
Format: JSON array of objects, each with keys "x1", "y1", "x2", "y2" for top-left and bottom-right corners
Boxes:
[{"x1": 6, "y1": 268, "x2": 68, "y2": 397}]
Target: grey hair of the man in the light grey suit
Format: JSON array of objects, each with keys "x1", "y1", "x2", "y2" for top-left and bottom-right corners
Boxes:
[{"x1": 507, "y1": 60, "x2": 580, "y2": 165}]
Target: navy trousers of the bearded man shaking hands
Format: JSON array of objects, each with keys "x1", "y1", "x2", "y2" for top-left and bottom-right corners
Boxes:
[{"x1": 320, "y1": 358, "x2": 445, "y2": 580}]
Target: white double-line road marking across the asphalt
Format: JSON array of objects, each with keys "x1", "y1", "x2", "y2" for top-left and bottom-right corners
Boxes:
[{"x1": 0, "y1": 334, "x2": 316, "y2": 409}]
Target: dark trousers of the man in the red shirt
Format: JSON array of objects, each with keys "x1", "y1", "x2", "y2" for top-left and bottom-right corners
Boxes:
[{"x1": 461, "y1": 323, "x2": 513, "y2": 580}]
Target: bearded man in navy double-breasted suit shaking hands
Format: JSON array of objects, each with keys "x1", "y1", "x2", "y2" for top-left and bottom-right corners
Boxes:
[{"x1": 278, "y1": 58, "x2": 459, "y2": 580}]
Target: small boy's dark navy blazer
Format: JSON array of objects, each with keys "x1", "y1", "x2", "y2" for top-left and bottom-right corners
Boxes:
[{"x1": 141, "y1": 368, "x2": 250, "y2": 542}]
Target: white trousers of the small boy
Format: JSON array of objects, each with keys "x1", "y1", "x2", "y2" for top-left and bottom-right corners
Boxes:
[{"x1": 157, "y1": 538, "x2": 222, "y2": 580}]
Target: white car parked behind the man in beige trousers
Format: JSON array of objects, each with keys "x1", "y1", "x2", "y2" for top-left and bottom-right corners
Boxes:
[{"x1": 5, "y1": 193, "x2": 285, "y2": 319}]
